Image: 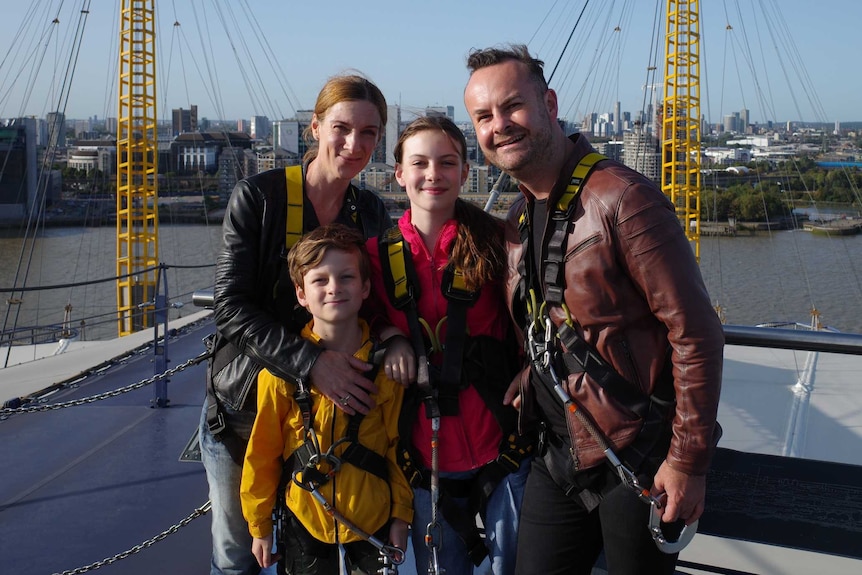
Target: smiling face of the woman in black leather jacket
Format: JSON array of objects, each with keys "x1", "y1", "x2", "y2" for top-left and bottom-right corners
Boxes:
[{"x1": 311, "y1": 100, "x2": 380, "y2": 180}]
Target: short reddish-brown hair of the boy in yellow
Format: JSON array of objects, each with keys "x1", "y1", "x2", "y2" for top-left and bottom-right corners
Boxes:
[{"x1": 287, "y1": 224, "x2": 371, "y2": 287}]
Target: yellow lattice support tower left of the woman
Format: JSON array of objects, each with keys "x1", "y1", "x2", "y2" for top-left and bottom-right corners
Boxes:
[{"x1": 117, "y1": 0, "x2": 159, "y2": 336}]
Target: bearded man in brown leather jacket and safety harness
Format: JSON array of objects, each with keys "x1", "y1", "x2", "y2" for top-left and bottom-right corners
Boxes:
[{"x1": 464, "y1": 45, "x2": 724, "y2": 575}]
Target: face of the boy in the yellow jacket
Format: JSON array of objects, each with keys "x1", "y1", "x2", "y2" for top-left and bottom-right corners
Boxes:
[{"x1": 296, "y1": 249, "x2": 371, "y2": 324}]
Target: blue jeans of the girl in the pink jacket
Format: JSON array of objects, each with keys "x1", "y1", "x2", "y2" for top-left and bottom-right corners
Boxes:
[{"x1": 411, "y1": 458, "x2": 532, "y2": 575}]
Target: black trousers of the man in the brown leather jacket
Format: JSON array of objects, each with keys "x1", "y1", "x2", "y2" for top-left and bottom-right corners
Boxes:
[{"x1": 515, "y1": 457, "x2": 677, "y2": 575}]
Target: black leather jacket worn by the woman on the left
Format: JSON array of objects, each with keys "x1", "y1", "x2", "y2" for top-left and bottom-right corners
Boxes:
[{"x1": 211, "y1": 169, "x2": 392, "y2": 411}]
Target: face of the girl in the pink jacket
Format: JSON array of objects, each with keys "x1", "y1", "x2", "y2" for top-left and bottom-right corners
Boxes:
[{"x1": 395, "y1": 130, "x2": 470, "y2": 217}]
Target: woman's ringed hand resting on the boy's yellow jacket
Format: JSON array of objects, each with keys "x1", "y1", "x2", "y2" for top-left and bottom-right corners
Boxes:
[{"x1": 310, "y1": 349, "x2": 377, "y2": 415}]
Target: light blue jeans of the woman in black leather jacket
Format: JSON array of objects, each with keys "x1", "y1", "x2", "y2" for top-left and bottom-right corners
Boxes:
[{"x1": 198, "y1": 403, "x2": 275, "y2": 575}]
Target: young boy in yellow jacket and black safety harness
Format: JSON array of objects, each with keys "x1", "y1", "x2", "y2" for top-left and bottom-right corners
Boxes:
[{"x1": 240, "y1": 224, "x2": 413, "y2": 575}]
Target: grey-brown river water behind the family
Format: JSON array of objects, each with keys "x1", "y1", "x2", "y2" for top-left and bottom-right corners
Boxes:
[{"x1": 5, "y1": 225, "x2": 862, "y2": 339}]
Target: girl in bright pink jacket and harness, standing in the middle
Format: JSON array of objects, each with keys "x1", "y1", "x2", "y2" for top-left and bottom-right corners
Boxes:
[{"x1": 368, "y1": 117, "x2": 529, "y2": 575}]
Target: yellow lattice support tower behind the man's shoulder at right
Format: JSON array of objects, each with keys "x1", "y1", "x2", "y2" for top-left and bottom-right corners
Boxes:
[{"x1": 660, "y1": 0, "x2": 701, "y2": 261}]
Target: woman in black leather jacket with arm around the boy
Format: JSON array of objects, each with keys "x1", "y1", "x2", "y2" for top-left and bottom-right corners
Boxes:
[{"x1": 200, "y1": 75, "x2": 391, "y2": 575}]
